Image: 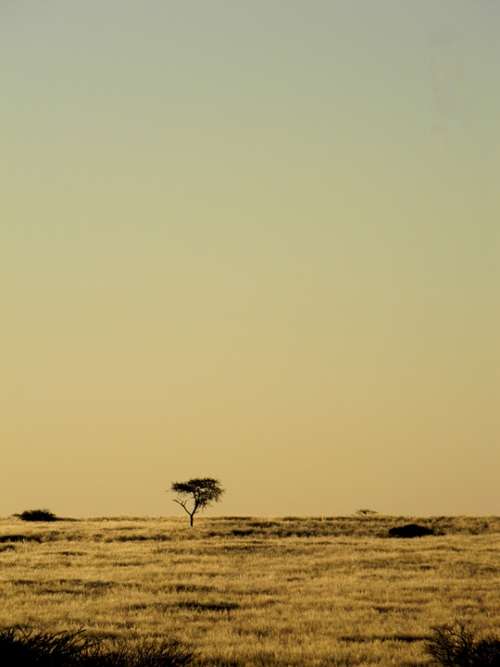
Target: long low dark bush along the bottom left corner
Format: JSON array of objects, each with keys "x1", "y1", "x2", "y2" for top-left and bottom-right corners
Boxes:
[{"x1": 0, "y1": 626, "x2": 194, "y2": 667}]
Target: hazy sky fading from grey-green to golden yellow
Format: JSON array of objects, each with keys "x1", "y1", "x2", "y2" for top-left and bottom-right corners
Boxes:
[{"x1": 0, "y1": 0, "x2": 500, "y2": 517}]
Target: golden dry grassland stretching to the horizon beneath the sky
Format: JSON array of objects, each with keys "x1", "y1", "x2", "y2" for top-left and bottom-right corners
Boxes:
[{"x1": 0, "y1": 516, "x2": 500, "y2": 666}]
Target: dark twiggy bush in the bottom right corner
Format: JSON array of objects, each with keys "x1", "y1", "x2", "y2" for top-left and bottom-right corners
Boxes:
[{"x1": 425, "y1": 621, "x2": 500, "y2": 667}]
